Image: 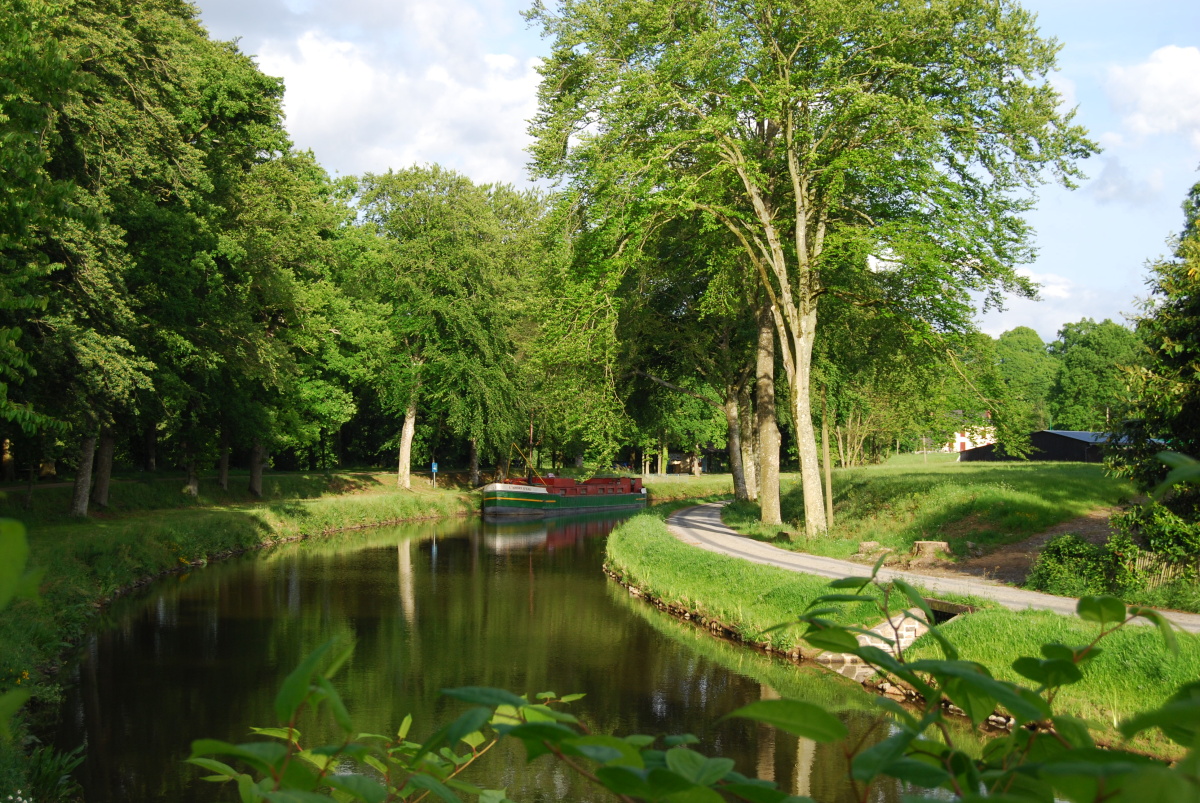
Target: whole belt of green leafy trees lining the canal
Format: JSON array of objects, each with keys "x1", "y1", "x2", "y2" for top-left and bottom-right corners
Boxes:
[{"x1": 0, "y1": 0, "x2": 1195, "y2": 534}]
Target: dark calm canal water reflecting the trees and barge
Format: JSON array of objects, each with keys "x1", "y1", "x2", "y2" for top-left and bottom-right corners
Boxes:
[{"x1": 58, "y1": 516, "x2": 899, "y2": 803}]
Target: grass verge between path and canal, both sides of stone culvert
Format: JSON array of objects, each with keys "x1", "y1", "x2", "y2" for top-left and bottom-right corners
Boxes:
[{"x1": 608, "y1": 515, "x2": 1200, "y2": 754}]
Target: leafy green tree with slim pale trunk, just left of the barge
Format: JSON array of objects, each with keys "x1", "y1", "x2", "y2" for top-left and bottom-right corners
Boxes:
[{"x1": 359, "y1": 166, "x2": 520, "y2": 487}]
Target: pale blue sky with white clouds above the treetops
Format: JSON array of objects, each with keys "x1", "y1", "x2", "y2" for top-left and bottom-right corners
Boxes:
[{"x1": 189, "y1": 0, "x2": 1200, "y2": 341}]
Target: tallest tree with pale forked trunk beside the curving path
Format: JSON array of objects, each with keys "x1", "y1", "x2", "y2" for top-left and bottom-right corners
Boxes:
[{"x1": 529, "y1": 0, "x2": 1094, "y2": 533}]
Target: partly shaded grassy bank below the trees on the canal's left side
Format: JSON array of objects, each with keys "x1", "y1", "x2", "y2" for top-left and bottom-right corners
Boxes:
[{"x1": 0, "y1": 474, "x2": 478, "y2": 791}]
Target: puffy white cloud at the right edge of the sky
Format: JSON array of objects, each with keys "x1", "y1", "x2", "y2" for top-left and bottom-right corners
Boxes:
[{"x1": 1108, "y1": 44, "x2": 1200, "y2": 149}]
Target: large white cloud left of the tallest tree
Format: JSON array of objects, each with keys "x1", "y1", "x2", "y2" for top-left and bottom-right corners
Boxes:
[{"x1": 259, "y1": 30, "x2": 539, "y2": 182}]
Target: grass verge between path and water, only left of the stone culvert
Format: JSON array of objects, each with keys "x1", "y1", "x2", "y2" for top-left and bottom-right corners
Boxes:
[{"x1": 607, "y1": 504, "x2": 876, "y2": 651}]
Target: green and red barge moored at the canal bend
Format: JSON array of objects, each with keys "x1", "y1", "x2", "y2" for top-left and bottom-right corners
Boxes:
[{"x1": 484, "y1": 477, "x2": 646, "y2": 516}]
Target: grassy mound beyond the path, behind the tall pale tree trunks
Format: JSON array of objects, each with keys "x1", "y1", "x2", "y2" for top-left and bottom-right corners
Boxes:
[{"x1": 724, "y1": 455, "x2": 1134, "y2": 558}]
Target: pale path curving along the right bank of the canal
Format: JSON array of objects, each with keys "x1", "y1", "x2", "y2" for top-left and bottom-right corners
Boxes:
[{"x1": 667, "y1": 502, "x2": 1200, "y2": 633}]
